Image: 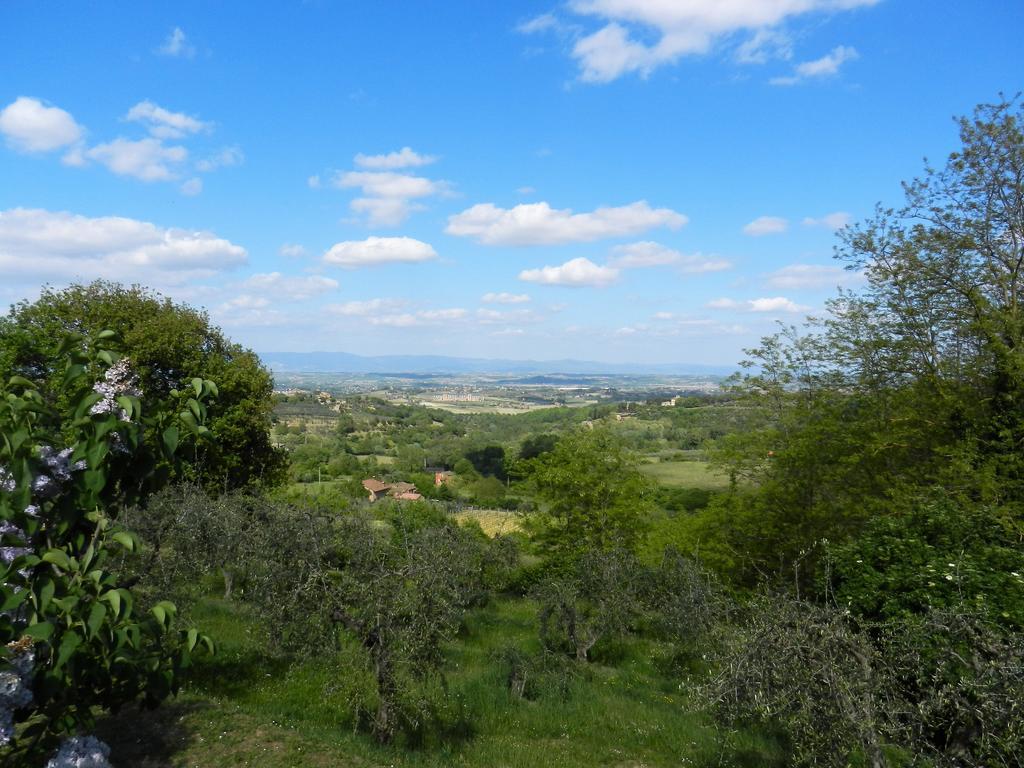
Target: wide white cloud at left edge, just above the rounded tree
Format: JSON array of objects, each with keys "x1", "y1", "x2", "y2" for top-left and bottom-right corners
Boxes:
[{"x1": 0, "y1": 208, "x2": 247, "y2": 285}]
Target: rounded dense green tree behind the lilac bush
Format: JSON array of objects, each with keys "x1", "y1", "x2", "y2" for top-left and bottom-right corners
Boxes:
[{"x1": 0, "y1": 281, "x2": 285, "y2": 489}]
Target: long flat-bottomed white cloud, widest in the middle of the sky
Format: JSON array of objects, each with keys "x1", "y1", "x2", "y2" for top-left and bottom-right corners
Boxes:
[{"x1": 444, "y1": 200, "x2": 687, "y2": 246}]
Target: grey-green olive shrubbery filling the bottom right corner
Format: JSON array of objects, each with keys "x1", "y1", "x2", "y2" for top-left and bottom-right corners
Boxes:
[{"x1": 705, "y1": 596, "x2": 1024, "y2": 768}]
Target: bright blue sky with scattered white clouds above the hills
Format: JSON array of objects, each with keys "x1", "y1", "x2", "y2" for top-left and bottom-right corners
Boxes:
[{"x1": 0, "y1": 0, "x2": 1024, "y2": 365}]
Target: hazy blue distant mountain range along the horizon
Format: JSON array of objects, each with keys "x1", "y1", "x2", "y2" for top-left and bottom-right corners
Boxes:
[{"x1": 260, "y1": 352, "x2": 736, "y2": 376}]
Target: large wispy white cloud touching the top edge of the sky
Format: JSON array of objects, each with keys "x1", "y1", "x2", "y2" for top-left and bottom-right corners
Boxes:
[{"x1": 552, "y1": 0, "x2": 879, "y2": 83}]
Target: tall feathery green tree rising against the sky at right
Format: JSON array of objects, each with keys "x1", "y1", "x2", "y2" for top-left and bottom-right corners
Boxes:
[{"x1": 708, "y1": 102, "x2": 1024, "y2": 584}]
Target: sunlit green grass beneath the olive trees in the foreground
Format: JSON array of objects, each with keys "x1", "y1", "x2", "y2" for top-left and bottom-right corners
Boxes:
[{"x1": 97, "y1": 599, "x2": 777, "y2": 768}]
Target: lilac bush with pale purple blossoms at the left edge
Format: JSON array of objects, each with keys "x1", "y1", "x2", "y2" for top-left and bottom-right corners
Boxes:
[{"x1": 0, "y1": 332, "x2": 217, "y2": 768}]
